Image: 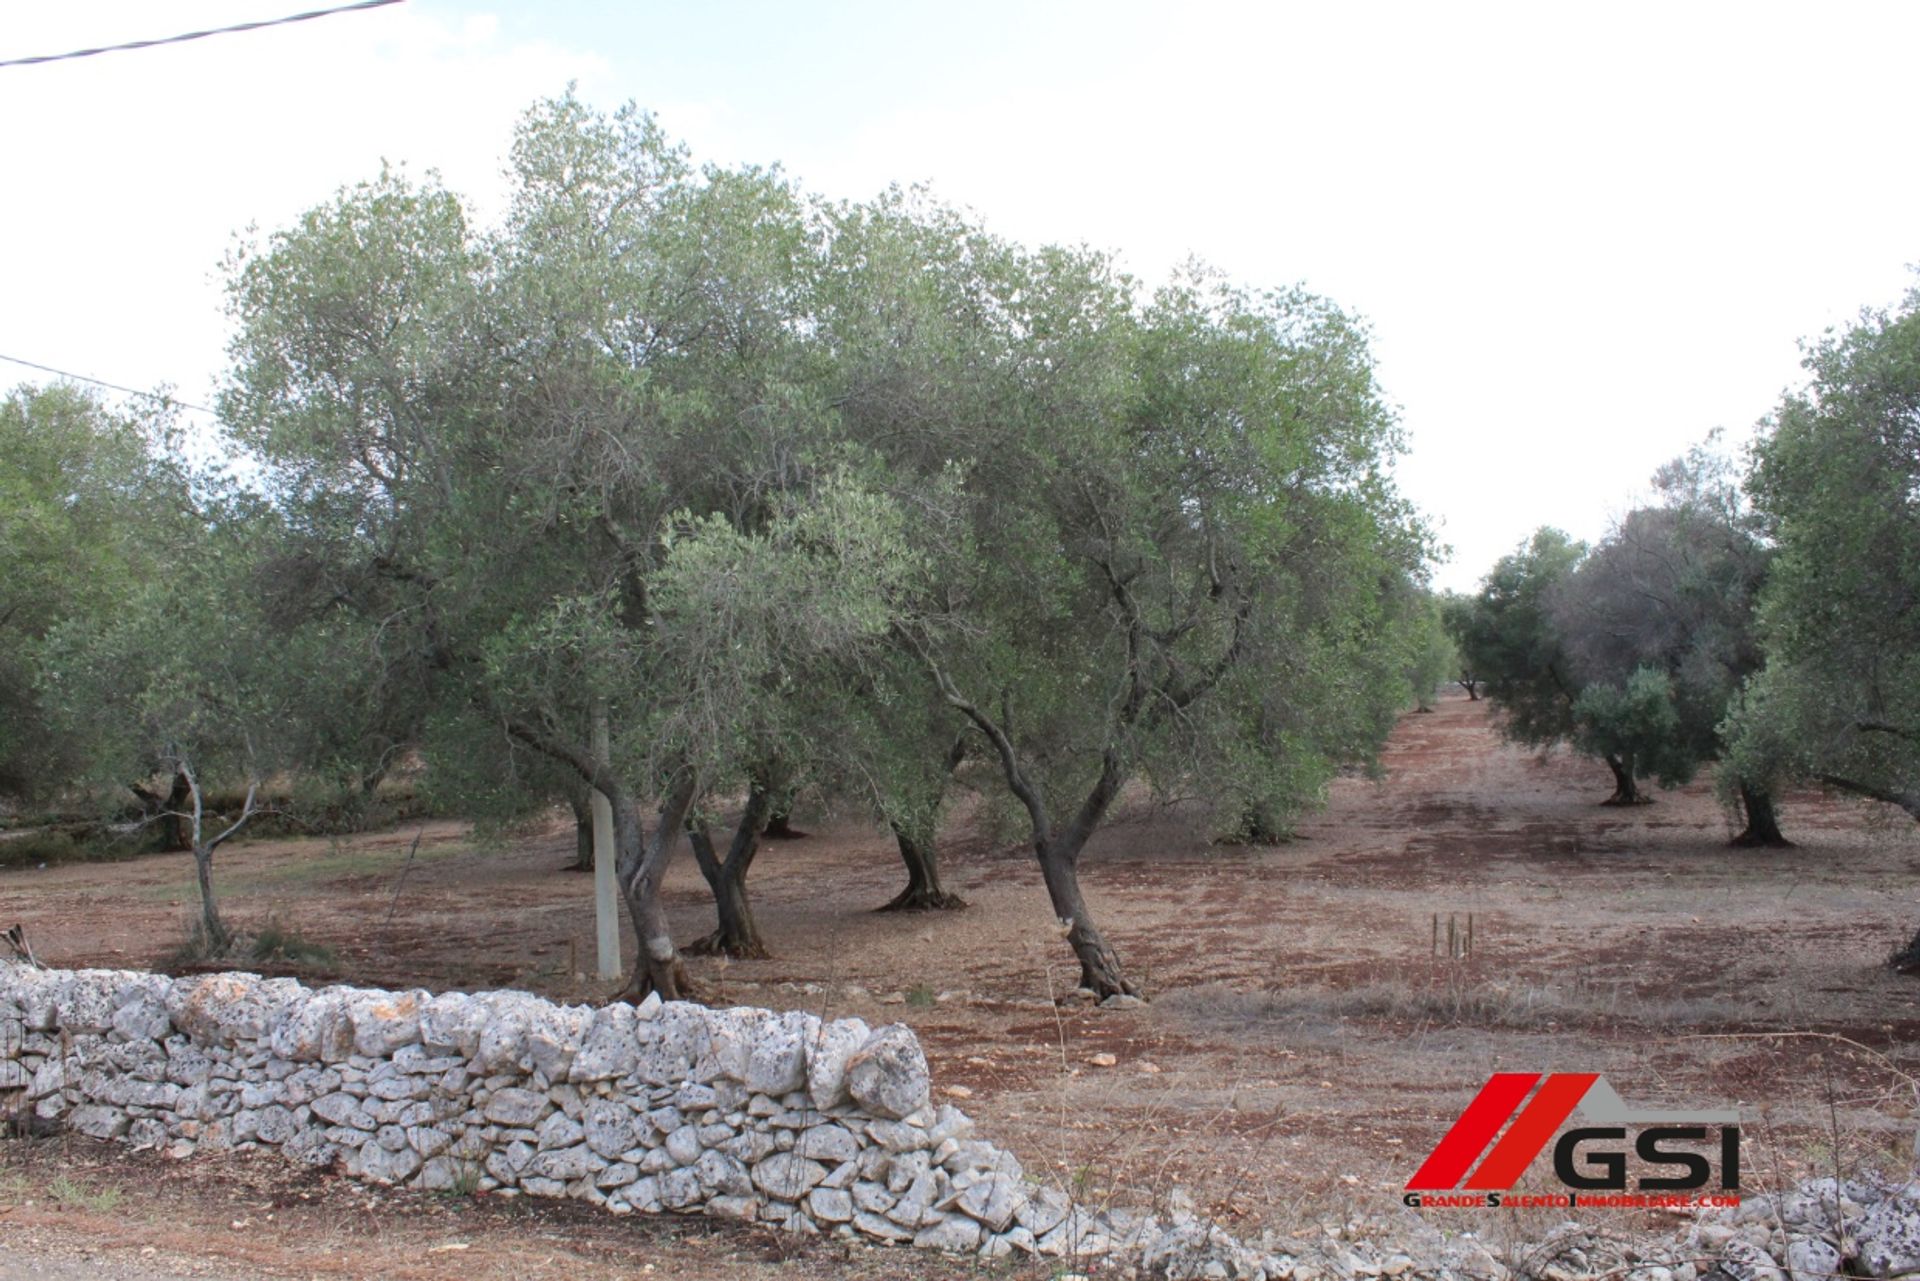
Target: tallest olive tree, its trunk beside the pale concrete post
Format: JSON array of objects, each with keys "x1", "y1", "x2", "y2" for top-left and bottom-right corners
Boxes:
[{"x1": 225, "y1": 98, "x2": 913, "y2": 995}]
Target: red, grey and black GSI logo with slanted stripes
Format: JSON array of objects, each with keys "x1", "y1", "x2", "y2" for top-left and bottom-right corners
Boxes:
[{"x1": 1407, "y1": 1072, "x2": 1740, "y2": 1204}]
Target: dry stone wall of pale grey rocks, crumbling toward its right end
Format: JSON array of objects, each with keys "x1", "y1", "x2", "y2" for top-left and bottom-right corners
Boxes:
[{"x1": 0, "y1": 962, "x2": 1267, "y2": 1277}]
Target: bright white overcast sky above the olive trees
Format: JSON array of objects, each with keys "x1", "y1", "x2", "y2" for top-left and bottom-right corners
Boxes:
[{"x1": 0, "y1": 0, "x2": 1920, "y2": 588}]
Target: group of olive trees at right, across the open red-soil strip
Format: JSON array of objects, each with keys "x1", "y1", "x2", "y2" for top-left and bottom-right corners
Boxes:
[{"x1": 1442, "y1": 290, "x2": 1920, "y2": 875}]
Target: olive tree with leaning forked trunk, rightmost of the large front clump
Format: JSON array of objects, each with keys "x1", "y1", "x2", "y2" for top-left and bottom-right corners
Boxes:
[{"x1": 902, "y1": 265, "x2": 1423, "y2": 997}]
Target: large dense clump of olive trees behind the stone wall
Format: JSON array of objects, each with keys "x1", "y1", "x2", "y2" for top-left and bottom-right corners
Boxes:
[{"x1": 0, "y1": 96, "x2": 1443, "y2": 997}]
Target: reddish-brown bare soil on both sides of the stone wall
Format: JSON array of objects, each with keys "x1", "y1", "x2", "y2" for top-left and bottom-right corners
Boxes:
[{"x1": 0, "y1": 695, "x2": 1920, "y2": 1277}]
